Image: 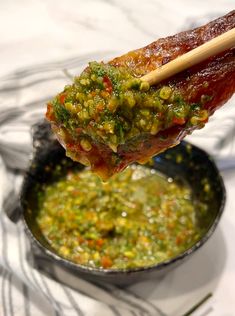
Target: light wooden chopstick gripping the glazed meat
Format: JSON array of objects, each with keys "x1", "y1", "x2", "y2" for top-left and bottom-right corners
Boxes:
[{"x1": 141, "y1": 28, "x2": 235, "y2": 85}]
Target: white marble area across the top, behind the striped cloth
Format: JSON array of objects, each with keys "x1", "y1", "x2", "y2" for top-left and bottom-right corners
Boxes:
[{"x1": 0, "y1": 0, "x2": 235, "y2": 75}]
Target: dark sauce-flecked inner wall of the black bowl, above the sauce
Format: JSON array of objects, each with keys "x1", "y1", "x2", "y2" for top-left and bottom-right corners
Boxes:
[{"x1": 21, "y1": 126, "x2": 225, "y2": 282}]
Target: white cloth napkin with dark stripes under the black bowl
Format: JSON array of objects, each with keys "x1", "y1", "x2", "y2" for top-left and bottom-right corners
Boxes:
[{"x1": 0, "y1": 52, "x2": 235, "y2": 316}]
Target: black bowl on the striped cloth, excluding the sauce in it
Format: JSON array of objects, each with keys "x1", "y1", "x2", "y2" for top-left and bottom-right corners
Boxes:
[{"x1": 21, "y1": 122, "x2": 225, "y2": 285}]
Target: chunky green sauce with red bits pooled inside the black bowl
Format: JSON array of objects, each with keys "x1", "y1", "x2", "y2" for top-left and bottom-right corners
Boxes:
[{"x1": 37, "y1": 165, "x2": 206, "y2": 269}]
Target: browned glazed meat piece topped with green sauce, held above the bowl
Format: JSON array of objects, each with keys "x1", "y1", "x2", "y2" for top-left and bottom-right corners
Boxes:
[{"x1": 46, "y1": 11, "x2": 235, "y2": 179}]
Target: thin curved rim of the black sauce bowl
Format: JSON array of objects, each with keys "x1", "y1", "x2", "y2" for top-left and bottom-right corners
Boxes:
[{"x1": 20, "y1": 141, "x2": 226, "y2": 276}]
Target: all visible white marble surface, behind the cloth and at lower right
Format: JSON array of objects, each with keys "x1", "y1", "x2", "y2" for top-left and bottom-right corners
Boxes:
[{"x1": 0, "y1": 0, "x2": 235, "y2": 316}]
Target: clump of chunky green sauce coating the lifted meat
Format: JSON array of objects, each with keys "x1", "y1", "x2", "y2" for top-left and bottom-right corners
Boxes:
[{"x1": 47, "y1": 62, "x2": 208, "y2": 152}]
